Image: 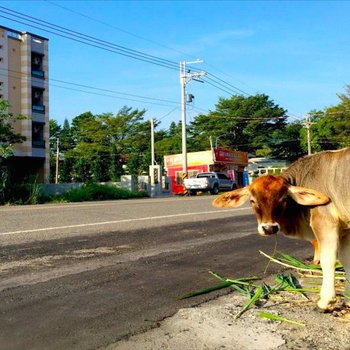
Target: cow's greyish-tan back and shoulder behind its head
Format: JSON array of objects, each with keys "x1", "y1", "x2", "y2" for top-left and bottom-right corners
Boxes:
[{"x1": 282, "y1": 147, "x2": 350, "y2": 225}]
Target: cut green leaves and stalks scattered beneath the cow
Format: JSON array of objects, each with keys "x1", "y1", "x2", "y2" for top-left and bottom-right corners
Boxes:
[{"x1": 180, "y1": 251, "x2": 348, "y2": 326}]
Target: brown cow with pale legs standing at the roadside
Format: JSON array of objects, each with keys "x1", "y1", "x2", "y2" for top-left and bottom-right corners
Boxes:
[{"x1": 213, "y1": 147, "x2": 350, "y2": 309}]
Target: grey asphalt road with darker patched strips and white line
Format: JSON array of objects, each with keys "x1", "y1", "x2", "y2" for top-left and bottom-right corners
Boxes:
[{"x1": 0, "y1": 196, "x2": 312, "y2": 350}]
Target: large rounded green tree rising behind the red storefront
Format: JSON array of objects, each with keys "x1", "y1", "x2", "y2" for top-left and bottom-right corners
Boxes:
[{"x1": 190, "y1": 94, "x2": 287, "y2": 155}]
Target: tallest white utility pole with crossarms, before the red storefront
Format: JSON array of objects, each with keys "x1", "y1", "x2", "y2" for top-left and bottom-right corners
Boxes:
[{"x1": 180, "y1": 60, "x2": 207, "y2": 177}]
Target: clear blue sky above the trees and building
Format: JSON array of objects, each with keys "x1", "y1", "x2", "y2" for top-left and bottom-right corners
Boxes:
[{"x1": 0, "y1": 0, "x2": 350, "y2": 128}]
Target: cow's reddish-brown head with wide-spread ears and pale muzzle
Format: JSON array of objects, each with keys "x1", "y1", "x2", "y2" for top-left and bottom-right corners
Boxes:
[{"x1": 213, "y1": 175, "x2": 330, "y2": 236}]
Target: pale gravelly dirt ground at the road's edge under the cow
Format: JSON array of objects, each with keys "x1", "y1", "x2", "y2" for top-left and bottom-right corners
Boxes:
[{"x1": 101, "y1": 276, "x2": 350, "y2": 350}]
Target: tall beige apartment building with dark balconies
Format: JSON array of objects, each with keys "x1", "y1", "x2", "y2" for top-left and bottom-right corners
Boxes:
[{"x1": 0, "y1": 26, "x2": 50, "y2": 182}]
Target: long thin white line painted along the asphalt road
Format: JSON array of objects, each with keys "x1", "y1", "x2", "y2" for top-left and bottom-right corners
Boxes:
[{"x1": 0, "y1": 208, "x2": 250, "y2": 236}]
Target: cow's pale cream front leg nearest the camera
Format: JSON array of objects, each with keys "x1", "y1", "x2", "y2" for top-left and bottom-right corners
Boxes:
[{"x1": 317, "y1": 232, "x2": 338, "y2": 310}]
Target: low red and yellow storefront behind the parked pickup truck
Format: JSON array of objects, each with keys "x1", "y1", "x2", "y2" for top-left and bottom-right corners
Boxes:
[{"x1": 164, "y1": 148, "x2": 248, "y2": 194}]
